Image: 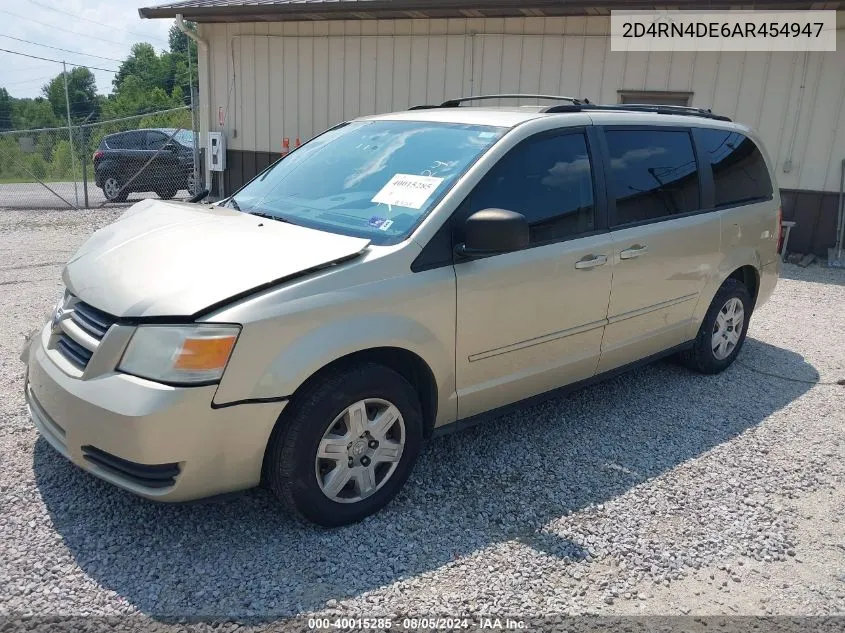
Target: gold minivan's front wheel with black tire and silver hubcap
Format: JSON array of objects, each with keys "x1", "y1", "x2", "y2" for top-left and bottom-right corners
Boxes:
[{"x1": 264, "y1": 363, "x2": 423, "y2": 527}]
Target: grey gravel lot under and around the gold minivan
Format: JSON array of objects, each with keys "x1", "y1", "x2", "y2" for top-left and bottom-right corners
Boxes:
[{"x1": 0, "y1": 209, "x2": 845, "y2": 618}]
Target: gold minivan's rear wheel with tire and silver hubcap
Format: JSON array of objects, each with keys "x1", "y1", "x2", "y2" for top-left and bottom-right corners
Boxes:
[{"x1": 680, "y1": 279, "x2": 754, "y2": 374}]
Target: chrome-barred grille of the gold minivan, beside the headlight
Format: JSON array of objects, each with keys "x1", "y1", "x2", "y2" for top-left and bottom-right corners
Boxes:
[{"x1": 54, "y1": 292, "x2": 117, "y2": 371}]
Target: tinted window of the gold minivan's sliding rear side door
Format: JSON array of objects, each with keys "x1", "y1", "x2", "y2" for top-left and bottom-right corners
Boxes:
[{"x1": 607, "y1": 128, "x2": 701, "y2": 225}]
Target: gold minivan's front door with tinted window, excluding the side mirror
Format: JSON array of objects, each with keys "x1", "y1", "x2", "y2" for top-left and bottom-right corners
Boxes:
[{"x1": 455, "y1": 129, "x2": 612, "y2": 418}]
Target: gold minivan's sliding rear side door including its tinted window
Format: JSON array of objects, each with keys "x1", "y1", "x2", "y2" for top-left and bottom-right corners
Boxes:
[{"x1": 599, "y1": 126, "x2": 720, "y2": 372}]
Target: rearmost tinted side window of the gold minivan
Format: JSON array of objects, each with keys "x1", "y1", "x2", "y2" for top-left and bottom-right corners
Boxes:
[{"x1": 697, "y1": 128, "x2": 772, "y2": 207}]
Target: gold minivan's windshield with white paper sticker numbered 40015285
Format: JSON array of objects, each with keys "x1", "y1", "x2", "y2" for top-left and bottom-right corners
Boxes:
[{"x1": 228, "y1": 120, "x2": 506, "y2": 244}]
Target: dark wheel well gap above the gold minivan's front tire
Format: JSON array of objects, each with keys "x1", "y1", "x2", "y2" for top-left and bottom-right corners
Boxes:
[{"x1": 291, "y1": 347, "x2": 437, "y2": 437}]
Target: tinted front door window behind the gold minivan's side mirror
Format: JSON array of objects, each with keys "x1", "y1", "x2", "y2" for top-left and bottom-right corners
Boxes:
[{"x1": 469, "y1": 133, "x2": 595, "y2": 244}]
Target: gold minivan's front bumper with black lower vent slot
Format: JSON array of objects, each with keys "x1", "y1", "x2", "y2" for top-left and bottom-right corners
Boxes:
[{"x1": 25, "y1": 325, "x2": 286, "y2": 501}]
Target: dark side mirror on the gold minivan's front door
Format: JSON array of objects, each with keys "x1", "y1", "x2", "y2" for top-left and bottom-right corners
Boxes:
[{"x1": 455, "y1": 209, "x2": 528, "y2": 258}]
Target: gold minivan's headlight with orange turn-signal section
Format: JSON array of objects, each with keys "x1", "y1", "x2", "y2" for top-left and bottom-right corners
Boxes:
[{"x1": 118, "y1": 325, "x2": 240, "y2": 384}]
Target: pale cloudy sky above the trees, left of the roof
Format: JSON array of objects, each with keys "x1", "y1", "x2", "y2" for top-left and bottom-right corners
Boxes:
[{"x1": 0, "y1": 0, "x2": 173, "y2": 97}]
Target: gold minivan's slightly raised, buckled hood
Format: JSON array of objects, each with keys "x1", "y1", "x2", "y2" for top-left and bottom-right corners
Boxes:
[{"x1": 63, "y1": 200, "x2": 369, "y2": 317}]
